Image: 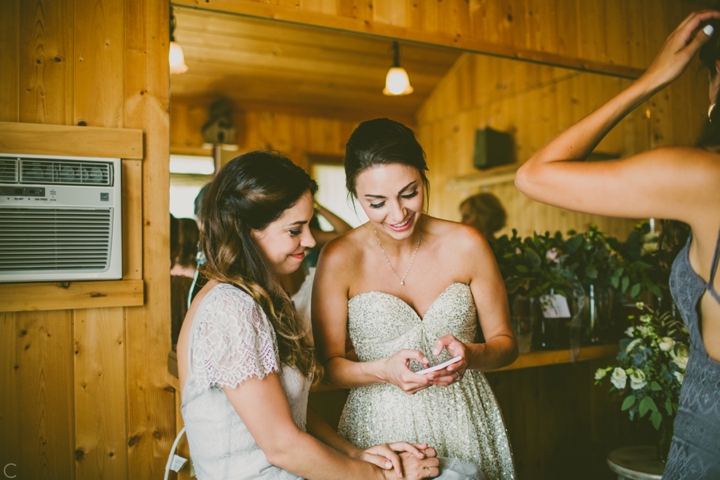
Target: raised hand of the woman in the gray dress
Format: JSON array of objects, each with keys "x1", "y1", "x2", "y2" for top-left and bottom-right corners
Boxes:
[{"x1": 641, "y1": 10, "x2": 720, "y2": 89}]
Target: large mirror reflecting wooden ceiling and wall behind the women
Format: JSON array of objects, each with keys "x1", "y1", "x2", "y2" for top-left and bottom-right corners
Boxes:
[{"x1": 170, "y1": 7, "x2": 651, "y2": 344}]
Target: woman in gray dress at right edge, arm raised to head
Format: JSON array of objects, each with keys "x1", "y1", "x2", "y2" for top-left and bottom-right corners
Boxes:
[{"x1": 515, "y1": 11, "x2": 720, "y2": 479}]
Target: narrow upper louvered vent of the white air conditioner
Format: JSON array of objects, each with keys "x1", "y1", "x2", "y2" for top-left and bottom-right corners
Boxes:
[{"x1": 20, "y1": 158, "x2": 112, "y2": 186}]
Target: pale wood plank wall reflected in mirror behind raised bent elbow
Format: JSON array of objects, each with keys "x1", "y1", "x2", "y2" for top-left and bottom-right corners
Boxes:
[{"x1": 417, "y1": 47, "x2": 707, "y2": 238}]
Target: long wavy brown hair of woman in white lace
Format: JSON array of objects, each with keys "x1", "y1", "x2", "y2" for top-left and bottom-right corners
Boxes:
[{"x1": 200, "y1": 152, "x2": 320, "y2": 378}]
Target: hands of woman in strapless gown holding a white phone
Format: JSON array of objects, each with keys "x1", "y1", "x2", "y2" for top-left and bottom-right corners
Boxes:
[{"x1": 385, "y1": 335, "x2": 468, "y2": 395}]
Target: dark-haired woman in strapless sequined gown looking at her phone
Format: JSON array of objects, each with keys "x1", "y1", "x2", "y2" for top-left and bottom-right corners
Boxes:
[{"x1": 312, "y1": 119, "x2": 517, "y2": 480}]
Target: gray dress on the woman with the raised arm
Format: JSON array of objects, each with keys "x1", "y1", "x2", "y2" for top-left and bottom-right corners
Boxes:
[{"x1": 663, "y1": 232, "x2": 720, "y2": 480}]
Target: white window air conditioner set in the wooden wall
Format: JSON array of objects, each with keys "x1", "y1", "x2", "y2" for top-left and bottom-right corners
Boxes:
[{"x1": 0, "y1": 153, "x2": 122, "y2": 283}]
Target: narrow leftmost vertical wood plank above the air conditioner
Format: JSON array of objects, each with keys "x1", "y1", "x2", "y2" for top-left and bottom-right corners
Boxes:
[{"x1": 0, "y1": 0, "x2": 20, "y2": 122}]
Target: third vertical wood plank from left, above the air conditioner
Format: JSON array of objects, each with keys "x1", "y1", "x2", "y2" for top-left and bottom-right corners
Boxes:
[{"x1": 73, "y1": 0, "x2": 124, "y2": 127}]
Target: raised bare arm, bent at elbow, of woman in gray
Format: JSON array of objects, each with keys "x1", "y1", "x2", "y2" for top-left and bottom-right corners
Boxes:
[{"x1": 515, "y1": 11, "x2": 720, "y2": 223}]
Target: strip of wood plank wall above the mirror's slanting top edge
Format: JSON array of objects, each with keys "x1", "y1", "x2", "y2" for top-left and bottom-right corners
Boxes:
[{"x1": 174, "y1": 0, "x2": 714, "y2": 76}]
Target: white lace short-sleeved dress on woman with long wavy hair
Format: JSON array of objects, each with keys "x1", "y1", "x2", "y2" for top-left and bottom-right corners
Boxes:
[{"x1": 182, "y1": 284, "x2": 310, "y2": 480}]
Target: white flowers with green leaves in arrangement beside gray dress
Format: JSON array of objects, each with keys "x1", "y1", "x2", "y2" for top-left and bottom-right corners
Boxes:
[{"x1": 595, "y1": 303, "x2": 690, "y2": 459}]
